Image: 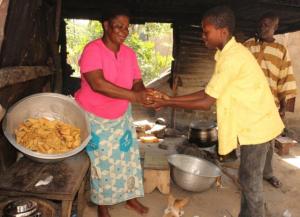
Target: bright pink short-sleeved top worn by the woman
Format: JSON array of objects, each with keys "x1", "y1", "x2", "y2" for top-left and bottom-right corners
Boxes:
[{"x1": 75, "y1": 39, "x2": 141, "y2": 119}]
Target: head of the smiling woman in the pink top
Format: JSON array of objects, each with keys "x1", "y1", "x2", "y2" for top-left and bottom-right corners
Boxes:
[{"x1": 102, "y1": 7, "x2": 130, "y2": 45}]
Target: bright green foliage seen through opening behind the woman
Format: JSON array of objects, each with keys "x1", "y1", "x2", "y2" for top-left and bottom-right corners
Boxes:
[{"x1": 66, "y1": 20, "x2": 172, "y2": 83}]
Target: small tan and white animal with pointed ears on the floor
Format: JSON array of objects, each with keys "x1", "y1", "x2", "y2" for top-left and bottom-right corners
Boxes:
[{"x1": 163, "y1": 194, "x2": 189, "y2": 217}]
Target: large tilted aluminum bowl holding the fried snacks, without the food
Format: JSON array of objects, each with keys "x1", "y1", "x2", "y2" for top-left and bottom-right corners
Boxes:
[{"x1": 2, "y1": 93, "x2": 91, "y2": 162}]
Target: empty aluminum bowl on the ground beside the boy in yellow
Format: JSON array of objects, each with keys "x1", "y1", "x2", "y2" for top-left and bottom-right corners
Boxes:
[{"x1": 168, "y1": 154, "x2": 221, "y2": 192}]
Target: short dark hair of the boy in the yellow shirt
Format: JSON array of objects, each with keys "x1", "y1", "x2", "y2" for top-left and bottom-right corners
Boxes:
[{"x1": 202, "y1": 6, "x2": 235, "y2": 34}]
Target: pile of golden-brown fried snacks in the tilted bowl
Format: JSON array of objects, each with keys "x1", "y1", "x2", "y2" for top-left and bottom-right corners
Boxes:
[{"x1": 15, "y1": 118, "x2": 81, "y2": 154}]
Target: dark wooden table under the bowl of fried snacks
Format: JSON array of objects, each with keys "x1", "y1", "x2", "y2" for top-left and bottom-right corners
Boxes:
[{"x1": 0, "y1": 152, "x2": 90, "y2": 217}]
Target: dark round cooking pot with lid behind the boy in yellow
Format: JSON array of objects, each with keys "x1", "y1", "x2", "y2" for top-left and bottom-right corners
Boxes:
[{"x1": 188, "y1": 121, "x2": 218, "y2": 148}]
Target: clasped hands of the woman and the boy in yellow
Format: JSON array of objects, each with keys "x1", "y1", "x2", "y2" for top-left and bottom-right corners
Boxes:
[{"x1": 141, "y1": 88, "x2": 170, "y2": 110}]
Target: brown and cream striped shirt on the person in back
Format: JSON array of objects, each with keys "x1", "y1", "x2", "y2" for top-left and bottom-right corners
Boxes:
[{"x1": 244, "y1": 38, "x2": 297, "y2": 107}]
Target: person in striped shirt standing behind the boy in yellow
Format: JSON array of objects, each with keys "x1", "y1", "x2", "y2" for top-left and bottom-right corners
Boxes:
[{"x1": 244, "y1": 12, "x2": 296, "y2": 188}]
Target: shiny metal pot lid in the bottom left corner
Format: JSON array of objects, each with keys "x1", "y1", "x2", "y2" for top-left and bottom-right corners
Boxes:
[{"x1": 3, "y1": 199, "x2": 38, "y2": 216}]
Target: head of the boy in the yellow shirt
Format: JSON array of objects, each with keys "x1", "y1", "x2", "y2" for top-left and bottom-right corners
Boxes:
[{"x1": 202, "y1": 6, "x2": 235, "y2": 48}]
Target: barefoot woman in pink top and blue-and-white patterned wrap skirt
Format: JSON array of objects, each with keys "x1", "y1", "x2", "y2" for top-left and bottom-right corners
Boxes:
[{"x1": 75, "y1": 6, "x2": 151, "y2": 217}]
